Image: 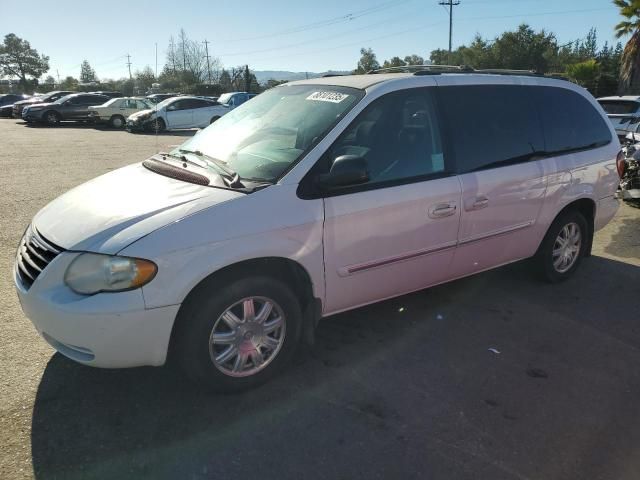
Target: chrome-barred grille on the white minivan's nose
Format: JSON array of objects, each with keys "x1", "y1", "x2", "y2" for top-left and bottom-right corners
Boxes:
[{"x1": 16, "y1": 227, "x2": 64, "y2": 290}]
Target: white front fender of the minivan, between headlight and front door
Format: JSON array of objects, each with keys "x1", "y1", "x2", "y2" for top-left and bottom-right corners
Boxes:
[{"x1": 119, "y1": 185, "x2": 325, "y2": 308}]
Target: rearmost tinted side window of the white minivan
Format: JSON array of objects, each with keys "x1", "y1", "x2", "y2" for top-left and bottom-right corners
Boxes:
[{"x1": 534, "y1": 87, "x2": 611, "y2": 153}]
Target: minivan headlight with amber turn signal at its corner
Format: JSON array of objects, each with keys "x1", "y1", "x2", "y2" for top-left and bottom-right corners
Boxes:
[{"x1": 64, "y1": 253, "x2": 158, "y2": 295}]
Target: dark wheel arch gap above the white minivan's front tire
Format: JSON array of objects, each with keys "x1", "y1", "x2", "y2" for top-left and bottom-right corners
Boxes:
[{"x1": 169, "y1": 256, "x2": 322, "y2": 358}]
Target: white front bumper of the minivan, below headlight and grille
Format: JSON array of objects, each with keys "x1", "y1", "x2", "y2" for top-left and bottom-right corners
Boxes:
[{"x1": 14, "y1": 252, "x2": 179, "y2": 368}]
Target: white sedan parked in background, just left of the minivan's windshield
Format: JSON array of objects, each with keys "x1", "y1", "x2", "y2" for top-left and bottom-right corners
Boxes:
[{"x1": 127, "y1": 97, "x2": 229, "y2": 132}]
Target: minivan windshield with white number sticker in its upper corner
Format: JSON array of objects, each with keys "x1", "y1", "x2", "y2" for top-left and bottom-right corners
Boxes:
[{"x1": 175, "y1": 85, "x2": 364, "y2": 182}]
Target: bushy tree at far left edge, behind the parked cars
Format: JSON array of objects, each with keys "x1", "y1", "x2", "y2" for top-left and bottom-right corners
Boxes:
[{"x1": 0, "y1": 33, "x2": 49, "y2": 89}]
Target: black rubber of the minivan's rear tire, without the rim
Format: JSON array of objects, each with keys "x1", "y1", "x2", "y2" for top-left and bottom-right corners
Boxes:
[{"x1": 533, "y1": 210, "x2": 591, "y2": 283}]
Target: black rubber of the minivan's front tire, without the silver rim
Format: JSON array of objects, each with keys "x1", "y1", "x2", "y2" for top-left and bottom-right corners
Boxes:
[{"x1": 172, "y1": 277, "x2": 302, "y2": 393}]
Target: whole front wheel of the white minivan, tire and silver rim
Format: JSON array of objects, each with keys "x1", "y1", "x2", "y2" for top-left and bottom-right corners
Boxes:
[{"x1": 175, "y1": 277, "x2": 302, "y2": 392}]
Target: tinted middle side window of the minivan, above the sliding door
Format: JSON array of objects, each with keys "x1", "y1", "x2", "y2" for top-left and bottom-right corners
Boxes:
[{"x1": 439, "y1": 85, "x2": 545, "y2": 173}]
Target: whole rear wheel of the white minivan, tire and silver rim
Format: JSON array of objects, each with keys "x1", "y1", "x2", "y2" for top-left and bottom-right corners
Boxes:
[{"x1": 535, "y1": 210, "x2": 589, "y2": 283}]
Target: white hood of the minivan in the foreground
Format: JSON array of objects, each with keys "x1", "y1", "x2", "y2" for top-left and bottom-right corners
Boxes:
[{"x1": 33, "y1": 164, "x2": 245, "y2": 254}]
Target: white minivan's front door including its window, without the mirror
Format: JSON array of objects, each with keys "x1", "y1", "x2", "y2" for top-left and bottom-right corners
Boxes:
[{"x1": 321, "y1": 88, "x2": 460, "y2": 313}]
